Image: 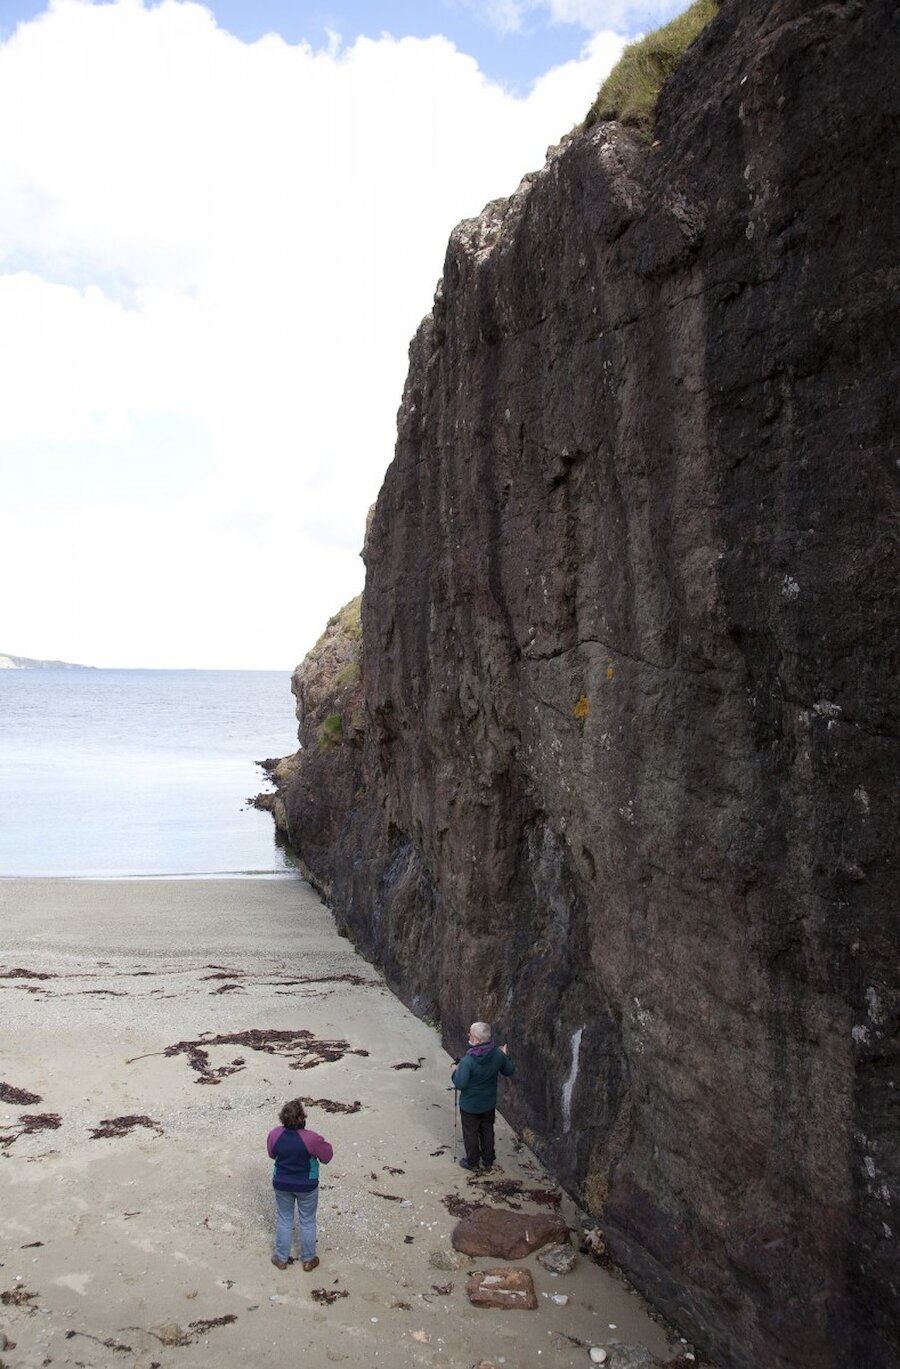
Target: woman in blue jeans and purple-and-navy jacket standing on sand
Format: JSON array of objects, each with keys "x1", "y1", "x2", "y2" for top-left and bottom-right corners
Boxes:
[{"x1": 266, "y1": 1098, "x2": 334, "y2": 1273}]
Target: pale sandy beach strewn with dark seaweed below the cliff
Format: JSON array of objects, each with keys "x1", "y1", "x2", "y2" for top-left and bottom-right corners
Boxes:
[{"x1": 0, "y1": 876, "x2": 670, "y2": 1369}]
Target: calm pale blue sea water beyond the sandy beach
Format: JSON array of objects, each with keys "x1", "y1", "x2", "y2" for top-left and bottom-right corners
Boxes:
[{"x1": 0, "y1": 669, "x2": 297, "y2": 876}]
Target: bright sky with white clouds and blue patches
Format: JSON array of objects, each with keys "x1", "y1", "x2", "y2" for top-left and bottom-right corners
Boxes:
[{"x1": 0, "y1": 0, "x2": 684, "y2": 671}]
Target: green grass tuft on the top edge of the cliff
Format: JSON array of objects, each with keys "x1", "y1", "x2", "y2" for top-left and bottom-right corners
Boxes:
[{"x1": 584, "y1": 0, "x2": 721, "y2": 134}]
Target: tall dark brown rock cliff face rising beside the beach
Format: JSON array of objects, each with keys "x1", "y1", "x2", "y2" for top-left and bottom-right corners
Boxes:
[{"x1": 276, "y1": 0, "x2": 900, "y2": 1369}]
